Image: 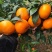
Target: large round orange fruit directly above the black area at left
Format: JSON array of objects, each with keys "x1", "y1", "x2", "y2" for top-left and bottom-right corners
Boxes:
[{"x1": 0, "y1": 20, "x2": 15, "y2": 35}]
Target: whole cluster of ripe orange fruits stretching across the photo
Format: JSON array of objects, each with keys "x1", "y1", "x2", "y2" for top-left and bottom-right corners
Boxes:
[{"x1": 0, "y1": 4, "x2": 52, "y2": 35}]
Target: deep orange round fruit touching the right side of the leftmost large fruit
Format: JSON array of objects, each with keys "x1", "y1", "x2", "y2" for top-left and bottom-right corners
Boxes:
[{"x1": 15, "y1": 19, "x2": 29, "y2": 34}]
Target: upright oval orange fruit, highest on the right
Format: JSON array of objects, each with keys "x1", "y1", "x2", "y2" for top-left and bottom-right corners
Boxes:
[{"x1": 39, "y1": 4, "x2": 51, "y2": 19}]
